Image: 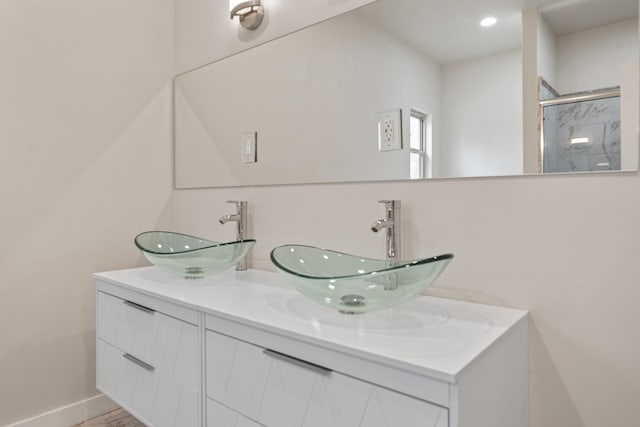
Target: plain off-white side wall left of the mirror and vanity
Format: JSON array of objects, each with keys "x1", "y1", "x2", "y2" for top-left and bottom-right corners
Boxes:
[{"x1": 0, "y1": 0, "x2": 173, "y2": 427}]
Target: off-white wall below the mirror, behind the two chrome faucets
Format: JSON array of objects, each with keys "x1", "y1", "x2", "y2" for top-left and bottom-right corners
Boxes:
[{"x1": 172, "y1": 2, "x2": 640, "y2": 427}]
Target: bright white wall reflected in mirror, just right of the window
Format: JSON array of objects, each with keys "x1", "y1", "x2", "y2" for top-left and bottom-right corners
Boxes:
[{"x1": 440, "y1": 49, "x2": 523, "y2": 177}]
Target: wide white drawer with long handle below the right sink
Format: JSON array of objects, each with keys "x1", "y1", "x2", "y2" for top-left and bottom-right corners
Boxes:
[{"x1": 205, "y1": 330, "x2": 449, "y2": 427}]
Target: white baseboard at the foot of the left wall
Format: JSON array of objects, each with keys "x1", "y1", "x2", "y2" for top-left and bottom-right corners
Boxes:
[{"x1": 5, "y1": 394, "x2": 118, "y2": 427}]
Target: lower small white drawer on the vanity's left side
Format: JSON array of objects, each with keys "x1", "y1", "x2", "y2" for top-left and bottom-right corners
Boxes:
[{"x1": 96, "y1": 339, "x2": 200, "y2": 427}]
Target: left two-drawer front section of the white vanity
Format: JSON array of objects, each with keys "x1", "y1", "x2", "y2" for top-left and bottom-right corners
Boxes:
[{"x1": 96, "y1": 283, "x2": 202, "y2": 427}]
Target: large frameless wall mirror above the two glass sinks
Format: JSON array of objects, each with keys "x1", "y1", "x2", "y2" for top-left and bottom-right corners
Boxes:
[{"x1": 174, "y1": 0, "x2": 639, "y2": 188}]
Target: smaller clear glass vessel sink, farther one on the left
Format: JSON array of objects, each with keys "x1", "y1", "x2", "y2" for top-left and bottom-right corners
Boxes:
[{"x1": 134, "y1": 231, "x2": 256, "y2": 279}]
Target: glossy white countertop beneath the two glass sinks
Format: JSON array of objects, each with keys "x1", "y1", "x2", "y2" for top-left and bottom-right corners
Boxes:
[{"x1": 94, "y1": 267, "x2": 527, "y2": 383}]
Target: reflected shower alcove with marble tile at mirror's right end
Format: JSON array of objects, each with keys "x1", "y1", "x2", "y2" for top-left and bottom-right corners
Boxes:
[{"x1": 538, "y1": 0, "x2": 638, "y2": 173}]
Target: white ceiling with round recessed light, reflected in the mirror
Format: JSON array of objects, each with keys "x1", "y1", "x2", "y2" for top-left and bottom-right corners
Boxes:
[{"x1": 360, "y1": 0, "x2": 638, "y2": 63}]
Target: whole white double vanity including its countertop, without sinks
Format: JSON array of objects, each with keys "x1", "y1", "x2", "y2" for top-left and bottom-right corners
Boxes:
[{"x1": 95, "y1": 267, "x2": 528, "y2": 427}]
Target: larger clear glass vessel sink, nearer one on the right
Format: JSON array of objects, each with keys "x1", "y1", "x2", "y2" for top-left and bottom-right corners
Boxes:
[{"x1": 271, "y1": 245, "x2": 453, "y2": 314}]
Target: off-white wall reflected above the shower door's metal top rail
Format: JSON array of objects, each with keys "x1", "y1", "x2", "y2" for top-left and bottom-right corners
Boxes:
[{"x1": 554, "y1": 19, "x2": 638, "y2": 94}]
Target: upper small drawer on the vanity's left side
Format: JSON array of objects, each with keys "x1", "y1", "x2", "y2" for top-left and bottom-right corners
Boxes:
[{"x1": 96, "y1": 292, "x2": 200, "y2": 389}]
